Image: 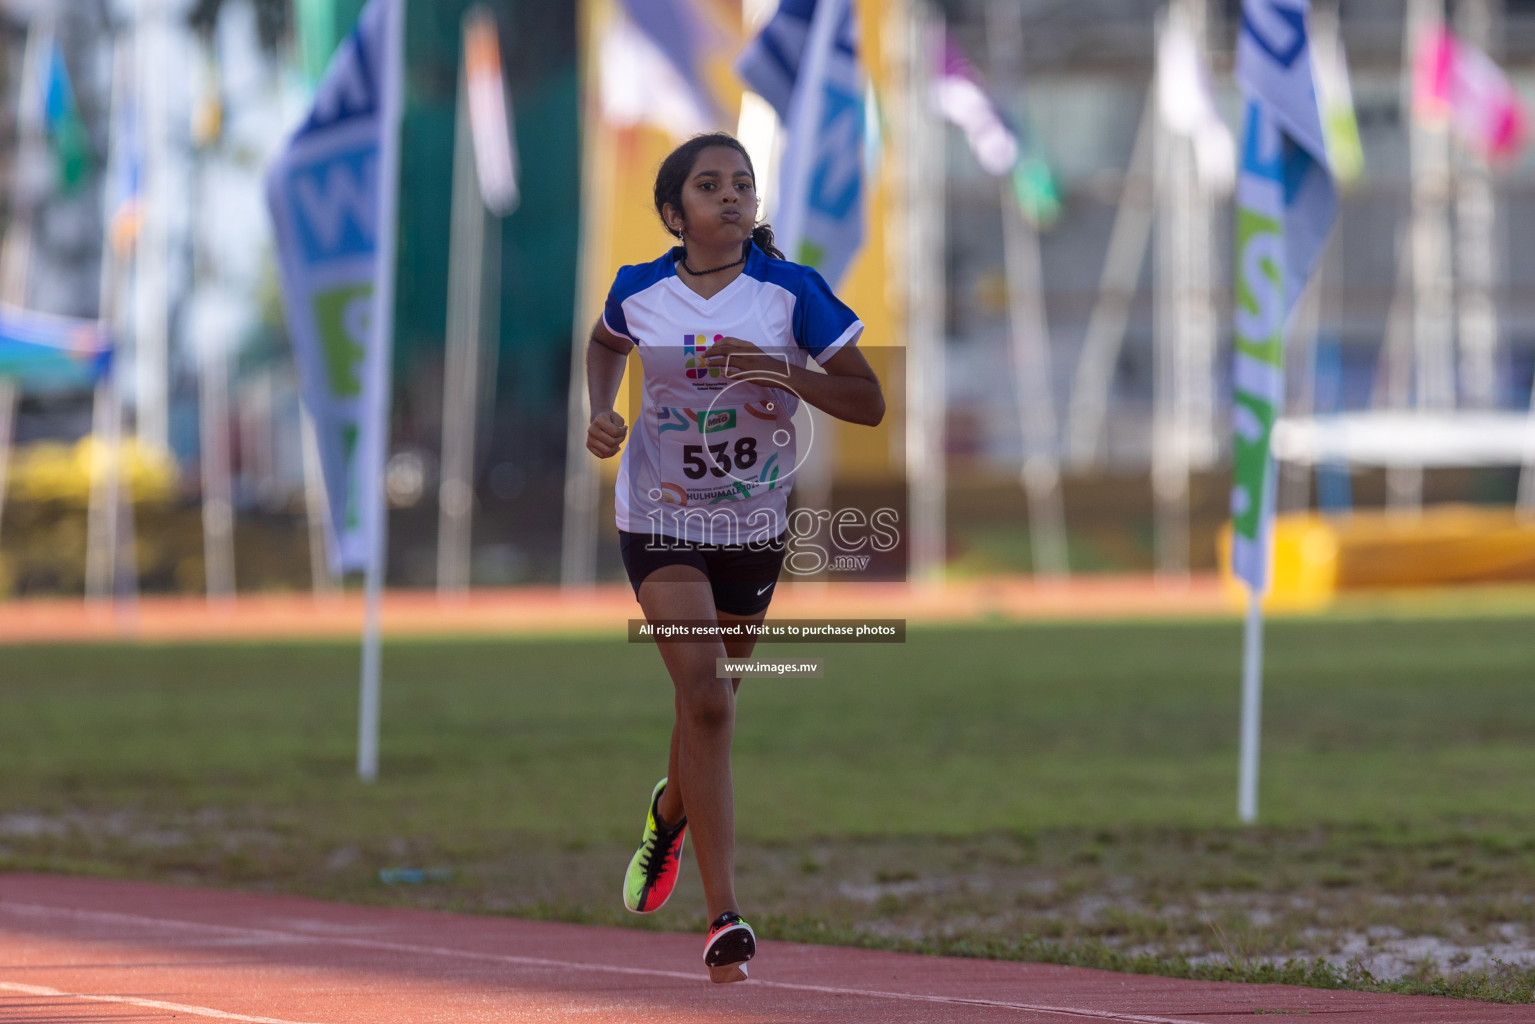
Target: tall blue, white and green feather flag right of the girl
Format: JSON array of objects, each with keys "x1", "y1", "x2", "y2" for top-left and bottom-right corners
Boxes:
[{"x1": 1231, "y1": 0, "x2": 1337, "y2": 594}]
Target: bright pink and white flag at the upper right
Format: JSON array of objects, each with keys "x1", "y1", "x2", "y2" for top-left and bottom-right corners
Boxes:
[{"x1": 1412, "y1": 25, "x2": 1524, "y2": 160}]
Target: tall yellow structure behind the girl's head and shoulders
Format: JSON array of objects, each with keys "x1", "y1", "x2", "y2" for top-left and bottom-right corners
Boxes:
[{"x1": 577, "y1": 0, "x2": 906, "y2": 481}]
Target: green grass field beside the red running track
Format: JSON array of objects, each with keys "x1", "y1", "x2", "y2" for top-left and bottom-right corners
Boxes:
[{"x1": 0, "y1": 617, "x2": 1535, "y2": 999}]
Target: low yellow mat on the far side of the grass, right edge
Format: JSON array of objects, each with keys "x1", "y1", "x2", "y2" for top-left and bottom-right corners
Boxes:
[{"x1": 1220, "y1": 505, "x2": 1535, "y2": 611}]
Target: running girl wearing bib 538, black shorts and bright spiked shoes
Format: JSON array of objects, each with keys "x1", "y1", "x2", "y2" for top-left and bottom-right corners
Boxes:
[{"x1": 586, "y1": 134, "x2": 884, "y2": 983}]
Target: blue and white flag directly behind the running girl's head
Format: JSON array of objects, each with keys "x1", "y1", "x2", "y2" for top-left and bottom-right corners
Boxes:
[{"x1": 735, "y1": 0, "x2": 866, "y2": 287}]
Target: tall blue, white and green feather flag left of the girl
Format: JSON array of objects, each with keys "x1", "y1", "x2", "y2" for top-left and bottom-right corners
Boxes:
[{"x1": 267, "y1": 0, "x2": 402, "y2": 573}]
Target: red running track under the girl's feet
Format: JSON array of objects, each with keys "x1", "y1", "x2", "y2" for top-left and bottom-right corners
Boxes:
[{"x1": 0, "y1": 874, "x2": 1535, "y2": 1024}]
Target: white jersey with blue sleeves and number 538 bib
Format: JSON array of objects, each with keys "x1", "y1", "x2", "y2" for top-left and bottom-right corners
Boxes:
[{"x1": 602, "y1": 244, "x2": 863, "y2": 543}]
